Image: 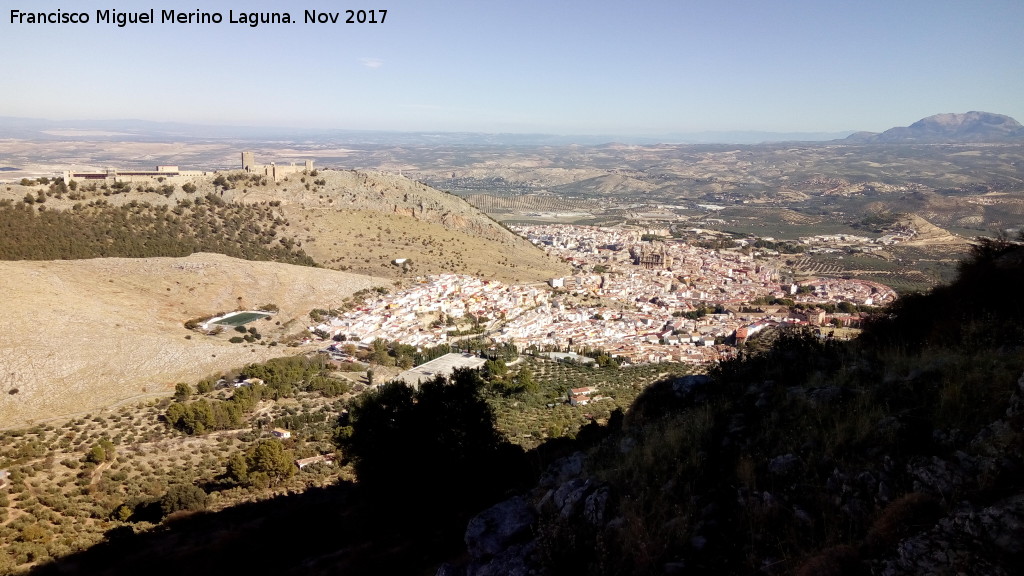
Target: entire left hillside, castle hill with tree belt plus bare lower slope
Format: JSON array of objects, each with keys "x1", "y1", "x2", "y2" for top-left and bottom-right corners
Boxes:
[{"x1": 0, "y1": 170, "x2": 565, "y2": 426}]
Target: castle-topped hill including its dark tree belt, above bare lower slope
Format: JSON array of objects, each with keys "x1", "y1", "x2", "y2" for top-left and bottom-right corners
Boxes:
[{"x1": 0, "y1": 166, "x2": 566, "y2": 281}]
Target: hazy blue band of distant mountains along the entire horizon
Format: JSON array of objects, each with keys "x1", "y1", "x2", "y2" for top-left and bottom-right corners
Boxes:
[{"x1": 0, "y1": 112, "x2": 1024, "y2": 146}]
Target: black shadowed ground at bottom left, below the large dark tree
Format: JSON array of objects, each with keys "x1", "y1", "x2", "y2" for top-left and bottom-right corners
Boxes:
[{"x1": 33, "y1": 484, "x2": 464, "y2": 575}]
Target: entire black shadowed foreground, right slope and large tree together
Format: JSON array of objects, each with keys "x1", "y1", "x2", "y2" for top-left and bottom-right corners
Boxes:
[{"x1": 22, "y1": 235, "x2": 1024, "y2": 574}]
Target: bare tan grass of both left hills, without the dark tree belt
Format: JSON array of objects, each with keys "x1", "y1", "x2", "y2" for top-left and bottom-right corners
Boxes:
[{"x1": 0, "y1": 166, "x2": 568, "y2": 427}]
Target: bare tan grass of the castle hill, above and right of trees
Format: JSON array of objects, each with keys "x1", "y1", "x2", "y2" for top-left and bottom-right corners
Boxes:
[{"x1": 0, "y1": 166, "x2": 569, "y2": 282}]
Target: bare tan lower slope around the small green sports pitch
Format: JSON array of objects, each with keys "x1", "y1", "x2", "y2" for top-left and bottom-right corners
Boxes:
[{"x1": 0, "y1": 254, "x2": 388, "y2": 427}]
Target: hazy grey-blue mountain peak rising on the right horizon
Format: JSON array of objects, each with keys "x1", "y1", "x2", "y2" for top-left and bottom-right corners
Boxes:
[{"x1": 844, "y1": 112, "x2": 1024, "y2": 143}]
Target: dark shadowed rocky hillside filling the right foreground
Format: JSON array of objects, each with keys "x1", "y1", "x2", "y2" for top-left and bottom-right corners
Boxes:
[{"x1": 445, "y1": 235, "x2": 1024, "y2": 576}]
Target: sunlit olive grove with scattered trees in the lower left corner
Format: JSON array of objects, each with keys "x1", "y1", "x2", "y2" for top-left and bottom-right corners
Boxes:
[{"x1": 0, "y1": 390, "x2": 346, "y2": 574}]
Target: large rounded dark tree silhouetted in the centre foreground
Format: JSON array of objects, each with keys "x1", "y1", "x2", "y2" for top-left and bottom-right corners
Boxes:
[{"x1": 339, "y1": 369, "x2": 528, "y2": 506}]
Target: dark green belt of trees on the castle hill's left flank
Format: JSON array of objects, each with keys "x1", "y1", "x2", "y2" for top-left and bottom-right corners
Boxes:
[{"x1": 0, "y1": 193, "x2": 314, "y2": 265}]
